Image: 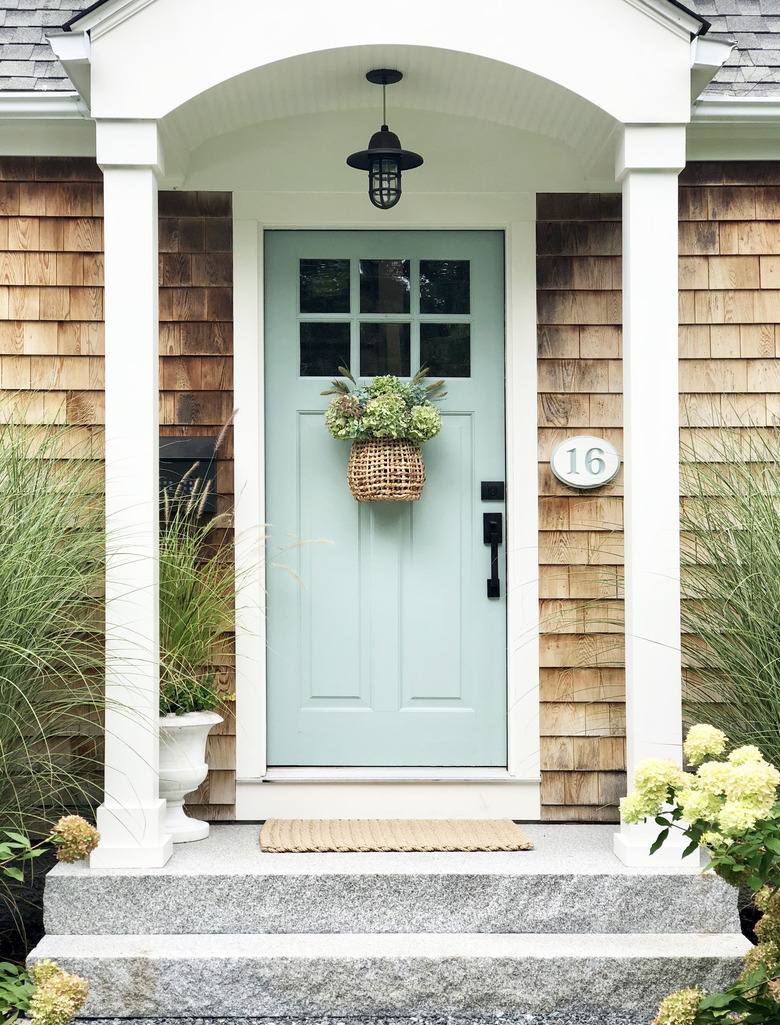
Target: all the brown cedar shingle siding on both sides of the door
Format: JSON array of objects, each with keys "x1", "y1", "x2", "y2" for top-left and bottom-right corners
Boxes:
[{"x1": 0, "y1": 158, "x2": 780, "y2": 821}]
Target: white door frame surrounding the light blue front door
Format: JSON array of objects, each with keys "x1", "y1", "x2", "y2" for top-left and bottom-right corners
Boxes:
[{"x1": 228, "y1": 193, "x2": 540, "y2": 819}]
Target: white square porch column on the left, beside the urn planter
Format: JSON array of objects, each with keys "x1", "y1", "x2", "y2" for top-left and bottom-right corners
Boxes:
[{"x1": 90, "y1": 122, "x2": 172, "y2": 868}]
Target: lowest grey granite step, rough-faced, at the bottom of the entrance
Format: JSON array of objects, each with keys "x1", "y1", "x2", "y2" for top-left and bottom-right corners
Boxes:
[{"x1": 32, "y1": 933, "x2": 749, "y2": 1019}]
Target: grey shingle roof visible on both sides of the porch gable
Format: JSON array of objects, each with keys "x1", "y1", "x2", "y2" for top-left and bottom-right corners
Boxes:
[{"x1": 0, "y1": 0, "x2": 780, "y2": 97}]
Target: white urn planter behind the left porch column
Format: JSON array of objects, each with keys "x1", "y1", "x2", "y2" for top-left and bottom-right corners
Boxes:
[{"x1": 160, "y1": 711, "x2": 222, "y2": 844}]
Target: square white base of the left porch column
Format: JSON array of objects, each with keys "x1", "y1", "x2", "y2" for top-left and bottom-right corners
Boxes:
[{"x1": 89, "y1": 800, "x2": 173, "y2": 868}]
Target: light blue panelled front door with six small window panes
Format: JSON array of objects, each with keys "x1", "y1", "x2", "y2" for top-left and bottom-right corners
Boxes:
[{"x1": 264, "y1": 231, "x2": 506, "y2": 766}]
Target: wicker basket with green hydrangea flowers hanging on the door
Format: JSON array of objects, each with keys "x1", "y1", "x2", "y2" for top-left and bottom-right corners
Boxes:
[{"x1": 323, "y1": 367, "x2": 446, "y2": 502}]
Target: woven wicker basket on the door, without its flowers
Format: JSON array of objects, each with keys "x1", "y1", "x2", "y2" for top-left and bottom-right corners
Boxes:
[{"x1": 346, "y1": 438, "x2": 425, "y2": 502}]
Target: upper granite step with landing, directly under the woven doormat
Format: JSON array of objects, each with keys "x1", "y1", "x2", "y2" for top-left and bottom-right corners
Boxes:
[{"x1": 45, "y1": 825, "x2": 739, "y2": 935}]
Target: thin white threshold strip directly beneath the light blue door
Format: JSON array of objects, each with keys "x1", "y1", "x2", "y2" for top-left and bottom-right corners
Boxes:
[{"x1": 255, "y1": 766, "x2": 538, "y2": 783}]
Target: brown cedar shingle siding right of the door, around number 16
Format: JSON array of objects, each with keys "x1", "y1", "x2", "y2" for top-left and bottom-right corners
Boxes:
[{"x1": 537, "y1": 161, "x2": 780, "y2": 821}]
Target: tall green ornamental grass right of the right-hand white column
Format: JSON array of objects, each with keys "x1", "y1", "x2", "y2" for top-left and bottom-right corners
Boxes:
[{"x1": 681, "y1": 424, "x2": 780, "y2": 765}]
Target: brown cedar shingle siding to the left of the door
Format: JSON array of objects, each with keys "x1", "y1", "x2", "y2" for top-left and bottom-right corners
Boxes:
[{"x1": 0, "y1": 157, "x2": 236, "y2": 819}]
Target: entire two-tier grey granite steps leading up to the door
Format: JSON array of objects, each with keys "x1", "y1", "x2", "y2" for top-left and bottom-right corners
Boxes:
[{"x1": 30, "y1": 823, "x2": 749, "y2": 1023}]
